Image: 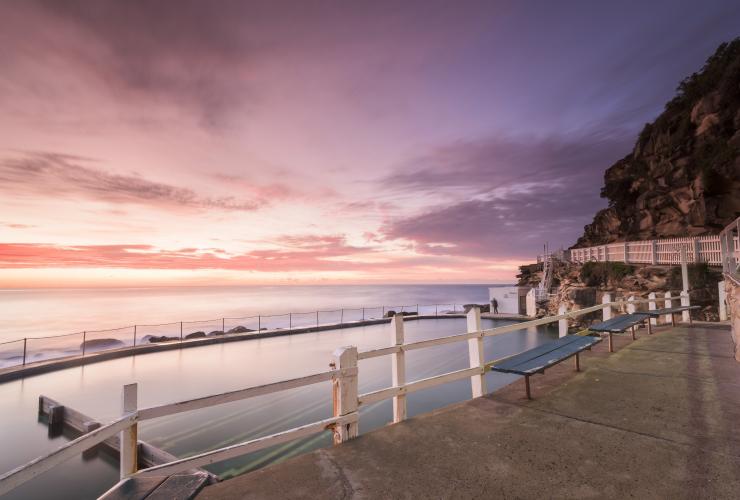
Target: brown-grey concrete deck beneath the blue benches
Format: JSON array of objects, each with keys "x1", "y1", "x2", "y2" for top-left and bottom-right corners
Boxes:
[{"x1": 198, "y1": 323, "x2": 740, "y2": 499}]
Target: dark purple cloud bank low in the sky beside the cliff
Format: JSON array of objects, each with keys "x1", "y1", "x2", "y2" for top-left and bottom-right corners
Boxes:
[{"x1": 382, "y1": 131, "x2": 632, "y2": 259}]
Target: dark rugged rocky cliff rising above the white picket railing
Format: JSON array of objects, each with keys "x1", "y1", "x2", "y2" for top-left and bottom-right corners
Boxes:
[{"x1": 575, "y1": 38, "x2": 740, "y2": 247}]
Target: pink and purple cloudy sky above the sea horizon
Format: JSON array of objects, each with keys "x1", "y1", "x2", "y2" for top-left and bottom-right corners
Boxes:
[{"x1": 0, "y1": 0, "x2": 740, "y2": 288}]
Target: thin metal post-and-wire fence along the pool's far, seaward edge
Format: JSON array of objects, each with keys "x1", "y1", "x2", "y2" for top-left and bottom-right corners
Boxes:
[{"x1": 0, "y1": 304, "x2": 472, "y2": 368}]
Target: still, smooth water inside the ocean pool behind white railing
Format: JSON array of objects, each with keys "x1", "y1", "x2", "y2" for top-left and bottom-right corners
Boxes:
[{"x1": 0, "y1": 318, "x2": 556, "y2": 498}]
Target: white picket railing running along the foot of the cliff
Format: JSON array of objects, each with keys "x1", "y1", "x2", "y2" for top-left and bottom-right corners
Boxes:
[{"x1": 570, "y1": 235, "x2": 724, "y2": 266}]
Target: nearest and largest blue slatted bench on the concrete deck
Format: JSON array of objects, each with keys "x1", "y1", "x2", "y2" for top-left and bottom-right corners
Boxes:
[{"x1": 491, "y1": 335, "x2": 601, "y2": 399}]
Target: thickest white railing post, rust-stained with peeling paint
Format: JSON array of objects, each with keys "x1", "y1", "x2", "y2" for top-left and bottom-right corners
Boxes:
[{"x1": 332, "y1": 346, "x2": 359, "y2": 444}]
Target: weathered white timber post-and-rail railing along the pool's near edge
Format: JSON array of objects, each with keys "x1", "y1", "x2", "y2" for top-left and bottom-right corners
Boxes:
[{"x1": 0, "y1": 293, "x2": 688, "y2": 495}]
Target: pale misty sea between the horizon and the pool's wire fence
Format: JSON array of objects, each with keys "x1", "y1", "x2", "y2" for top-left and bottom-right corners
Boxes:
[{"x1": 0, "y1": 285, "x2": 506, "y2": 342}]
